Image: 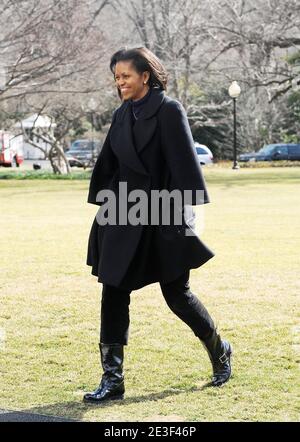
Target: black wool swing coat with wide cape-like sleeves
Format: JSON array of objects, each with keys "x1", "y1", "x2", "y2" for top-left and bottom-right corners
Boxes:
[{"x1": 86, "y1": 88, "x2": 214, "y2": 290}]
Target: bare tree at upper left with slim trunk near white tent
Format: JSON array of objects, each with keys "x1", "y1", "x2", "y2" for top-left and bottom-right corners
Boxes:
[{"x1": 0, "y1": 0, "x2": 115, "y2": 173}]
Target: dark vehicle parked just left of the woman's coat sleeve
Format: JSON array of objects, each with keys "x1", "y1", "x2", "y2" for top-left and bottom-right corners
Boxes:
[{"x1": 66, "y1": 140, "x2": 101, "y2": 168}]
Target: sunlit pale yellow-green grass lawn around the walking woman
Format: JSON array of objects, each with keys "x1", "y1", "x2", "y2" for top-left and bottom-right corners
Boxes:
[{"x1": 0, "y1": 167, "x2": 300, "y2": 421}]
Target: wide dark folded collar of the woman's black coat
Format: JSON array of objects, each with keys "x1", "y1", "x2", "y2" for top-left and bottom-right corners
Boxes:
[{"x1": 110, "y1": 88, "x2": 165, "y2": 175}]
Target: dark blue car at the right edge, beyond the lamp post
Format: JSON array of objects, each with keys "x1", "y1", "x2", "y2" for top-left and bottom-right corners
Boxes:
[{"x1": 239, "y1": 143, "x2": 300, "y2": 162}]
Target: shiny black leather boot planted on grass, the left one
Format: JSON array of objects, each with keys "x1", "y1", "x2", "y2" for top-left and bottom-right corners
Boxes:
[{"x1": 83, "y1": 343, "x2": 125, "y2": 403}]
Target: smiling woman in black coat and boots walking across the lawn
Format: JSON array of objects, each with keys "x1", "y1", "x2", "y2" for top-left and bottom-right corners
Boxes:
[{"x1": 84, "y1": 47, "x2": 232, "y2": 403}]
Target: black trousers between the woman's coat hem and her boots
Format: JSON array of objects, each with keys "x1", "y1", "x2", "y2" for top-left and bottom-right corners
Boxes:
[{"x1": 100, "y1": 270, "x2": 215, "y2": 345}]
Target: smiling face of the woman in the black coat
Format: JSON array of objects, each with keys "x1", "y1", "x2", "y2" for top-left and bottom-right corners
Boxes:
[{"x1": 115, "y1": 61, "x2": 150, "y2": 100}]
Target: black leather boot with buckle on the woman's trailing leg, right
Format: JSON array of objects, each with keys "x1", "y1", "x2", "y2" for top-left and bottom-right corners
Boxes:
[{"x1": 201, "y1": 329, "x2": 232, "y2": 387}]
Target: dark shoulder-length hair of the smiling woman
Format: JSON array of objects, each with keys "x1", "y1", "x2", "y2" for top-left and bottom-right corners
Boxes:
[{"x1": 109, "y1": 46, "x2": 168, "y2": 98}]
